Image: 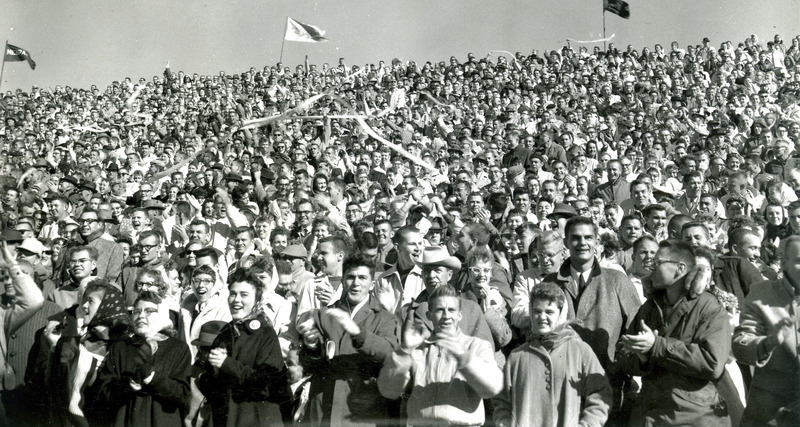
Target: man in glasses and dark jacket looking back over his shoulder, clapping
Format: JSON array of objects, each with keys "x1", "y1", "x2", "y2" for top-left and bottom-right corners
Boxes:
[{"x1": 618, "y1": 240, "x2": 731, "y2": 425}]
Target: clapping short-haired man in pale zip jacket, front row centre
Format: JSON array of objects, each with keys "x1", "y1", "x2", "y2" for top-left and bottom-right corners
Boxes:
[{"x1": 378, "y1": 284, "x2": 502, "y2": 425}]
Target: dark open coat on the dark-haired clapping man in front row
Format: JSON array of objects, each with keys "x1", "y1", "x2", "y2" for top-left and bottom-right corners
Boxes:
[{"x1": 300, "y1": 296, "x2": 400, "y2": 426}]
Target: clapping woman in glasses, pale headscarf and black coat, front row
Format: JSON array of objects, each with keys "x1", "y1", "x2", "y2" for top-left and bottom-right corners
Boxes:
[{"x1": 87, "y1": 291, "x2": 192, "y2": 427}]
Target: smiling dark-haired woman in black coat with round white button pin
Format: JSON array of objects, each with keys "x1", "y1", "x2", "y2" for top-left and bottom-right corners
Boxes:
[{"x1": 197, "y1": 268, "x2": 290, "y2": 426}]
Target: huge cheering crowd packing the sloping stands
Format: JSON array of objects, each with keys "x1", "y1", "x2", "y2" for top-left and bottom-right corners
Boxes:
[{"x1": 0, "y1": 31, "x2": 800, "y2": 426}]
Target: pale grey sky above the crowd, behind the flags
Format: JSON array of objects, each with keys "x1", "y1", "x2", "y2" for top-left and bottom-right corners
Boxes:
[{"x1": 0, "y1": 0, "x2": 800, "y2": 92}]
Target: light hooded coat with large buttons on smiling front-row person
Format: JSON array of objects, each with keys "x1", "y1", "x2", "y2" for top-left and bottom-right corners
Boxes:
[{"x1": 492, "y1": 327, "x2": 612, "y2": 427}]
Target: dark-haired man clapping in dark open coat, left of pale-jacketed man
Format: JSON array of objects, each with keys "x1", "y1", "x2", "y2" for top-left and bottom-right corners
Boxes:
[{"x1": 298, "y1": 256, "x2": 399, "y2": 425}]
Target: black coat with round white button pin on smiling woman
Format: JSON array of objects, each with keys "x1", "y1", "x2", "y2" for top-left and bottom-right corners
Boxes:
[{"x1": 197, "y1": 315, "x2": 290, "y2": 426}]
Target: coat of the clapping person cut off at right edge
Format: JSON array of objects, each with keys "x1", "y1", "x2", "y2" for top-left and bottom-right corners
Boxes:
[{"x1": 733, "y1": 277, "x2": 800, "y2": 426}]
